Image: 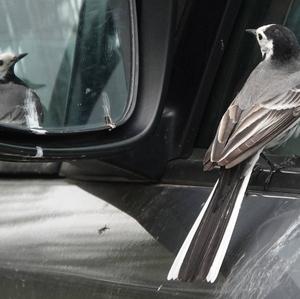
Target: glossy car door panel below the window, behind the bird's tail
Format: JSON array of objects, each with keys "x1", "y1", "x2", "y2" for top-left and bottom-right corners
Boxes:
[{"x1": 0, "y1": 180, "x2": 300, "y2": 299}]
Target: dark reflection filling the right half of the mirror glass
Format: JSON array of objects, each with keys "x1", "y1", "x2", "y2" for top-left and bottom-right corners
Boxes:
[{"x1": 49, "y1": 0, "x2": 131, "y2": 129}]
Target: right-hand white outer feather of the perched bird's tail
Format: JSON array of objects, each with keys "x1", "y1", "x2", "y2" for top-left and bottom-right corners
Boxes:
[{"x1": 206, "y1": 152, "x2": 261, "y2": 283}]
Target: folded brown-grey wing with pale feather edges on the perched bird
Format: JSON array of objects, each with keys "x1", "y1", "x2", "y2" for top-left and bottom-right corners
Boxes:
[{"x1": 204, "y1": 88, "x2": 300, "y2": 169}]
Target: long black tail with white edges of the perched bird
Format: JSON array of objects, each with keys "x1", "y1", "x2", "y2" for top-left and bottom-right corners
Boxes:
[{"x1": 168, "y1": 153, "x2": 259, "y2": 283}]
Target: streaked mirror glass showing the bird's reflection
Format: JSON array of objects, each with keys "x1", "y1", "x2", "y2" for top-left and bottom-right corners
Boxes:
[{"x1": 0, "y1": 0, "x2": 136, "y2": 133}]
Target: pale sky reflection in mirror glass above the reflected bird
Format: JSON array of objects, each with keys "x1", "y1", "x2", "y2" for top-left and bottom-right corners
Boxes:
[{"x1": 0, "y1": 0, "x2": 82, "y2": 107}]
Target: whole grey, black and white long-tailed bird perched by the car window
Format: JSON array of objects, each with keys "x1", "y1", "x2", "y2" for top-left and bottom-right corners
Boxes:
[{"x1": 167, "y1": 24, "x2": 300, "y2": 283}]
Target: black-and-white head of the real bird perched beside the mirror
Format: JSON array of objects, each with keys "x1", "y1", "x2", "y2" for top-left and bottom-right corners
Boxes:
[{"x1": 246, "y1": 24, "x2": 300, "y2": 62}]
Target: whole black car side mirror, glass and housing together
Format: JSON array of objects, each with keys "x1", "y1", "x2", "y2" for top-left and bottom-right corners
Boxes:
[{"x1": 0, "y1": 0, "x2": 173, "y2": 161}]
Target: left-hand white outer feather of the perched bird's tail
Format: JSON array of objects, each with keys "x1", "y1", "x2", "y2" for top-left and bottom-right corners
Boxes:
[{"x1": 167, "y1": 180, "x2": 219, "y2": 280}]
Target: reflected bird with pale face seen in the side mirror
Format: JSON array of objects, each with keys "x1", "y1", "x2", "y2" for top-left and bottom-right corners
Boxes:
[{"x1": 0, "y1": 52, "x2": 43, "y2": 129}]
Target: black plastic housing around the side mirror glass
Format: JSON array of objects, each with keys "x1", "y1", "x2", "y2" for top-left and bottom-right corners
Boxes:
[{"x1": 0, "y1": 0, "x2": 173, "y2": 161}]
